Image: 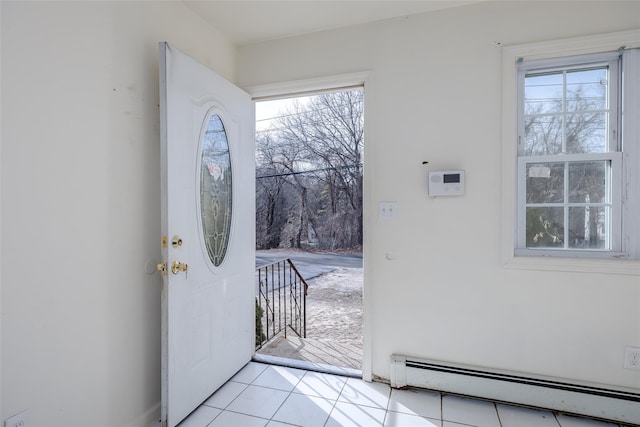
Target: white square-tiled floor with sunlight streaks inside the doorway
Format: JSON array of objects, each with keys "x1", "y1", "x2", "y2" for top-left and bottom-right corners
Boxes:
[{"x1": 180, "y1": 362, "x2": 618, "y2": 427}]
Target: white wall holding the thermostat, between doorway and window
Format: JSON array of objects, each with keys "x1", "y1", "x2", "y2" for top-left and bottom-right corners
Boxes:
[{"x1": 237, "y1": 1, "x2": 640, "y2": 389}]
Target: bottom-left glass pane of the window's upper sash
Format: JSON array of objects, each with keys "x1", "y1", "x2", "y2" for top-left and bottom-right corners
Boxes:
[{"x1": 524, "y1": 115, "x2": 562, "y2": 156}]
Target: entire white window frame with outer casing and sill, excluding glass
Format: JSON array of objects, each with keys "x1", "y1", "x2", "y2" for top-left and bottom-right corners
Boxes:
[{"x1": 502, "y1": 30, "x2": 640, "y2": 275}]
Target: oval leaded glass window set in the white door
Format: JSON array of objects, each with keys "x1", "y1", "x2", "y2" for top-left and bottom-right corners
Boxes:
[{"x1": 200, "y1": 114, "x2": 232, "y2": 267}]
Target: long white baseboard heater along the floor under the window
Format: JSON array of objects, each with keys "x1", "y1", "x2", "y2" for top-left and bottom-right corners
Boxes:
[{"x1": 390, "y1": 355, "x2": 640, "y2": 425}]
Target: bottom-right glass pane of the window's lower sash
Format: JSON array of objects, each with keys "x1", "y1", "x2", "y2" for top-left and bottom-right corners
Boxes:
[{"x1": 569, "y1": 206, "x2": 608, "y2": 249}]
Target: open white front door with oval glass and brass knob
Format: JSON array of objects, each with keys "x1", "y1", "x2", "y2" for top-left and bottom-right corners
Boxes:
[{"x1": 160, "y1": 43, "x2": 255, "y2": 427}]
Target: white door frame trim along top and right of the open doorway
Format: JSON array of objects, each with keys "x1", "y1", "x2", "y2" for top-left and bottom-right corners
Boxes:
[{"x1": 243, "y1": 71, "x2": 375, "y2": 381}]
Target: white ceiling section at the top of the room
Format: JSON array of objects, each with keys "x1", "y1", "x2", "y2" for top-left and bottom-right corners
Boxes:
[{"x1": 182, "y1": 0, "x2": 481, "y2": 45}]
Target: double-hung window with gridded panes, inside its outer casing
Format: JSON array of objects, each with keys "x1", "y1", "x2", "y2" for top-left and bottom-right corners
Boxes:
[{"x1": 516, "y1": 54, "x2": 622, "y2": 256}]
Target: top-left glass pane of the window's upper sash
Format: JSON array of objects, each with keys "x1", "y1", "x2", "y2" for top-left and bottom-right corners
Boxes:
[{"x1": 524, "y1": 73, "x2": 562, "y2": 115}]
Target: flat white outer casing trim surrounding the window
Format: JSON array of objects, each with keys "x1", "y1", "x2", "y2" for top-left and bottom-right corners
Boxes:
[{"x1": 501, "y1": 29, "x2": 640, "y2": 275}]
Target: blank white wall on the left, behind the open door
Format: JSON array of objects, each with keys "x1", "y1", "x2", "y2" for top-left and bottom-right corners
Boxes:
[{"x1": 0, "y1": 1, "x2": 235, "y2": 427}]
